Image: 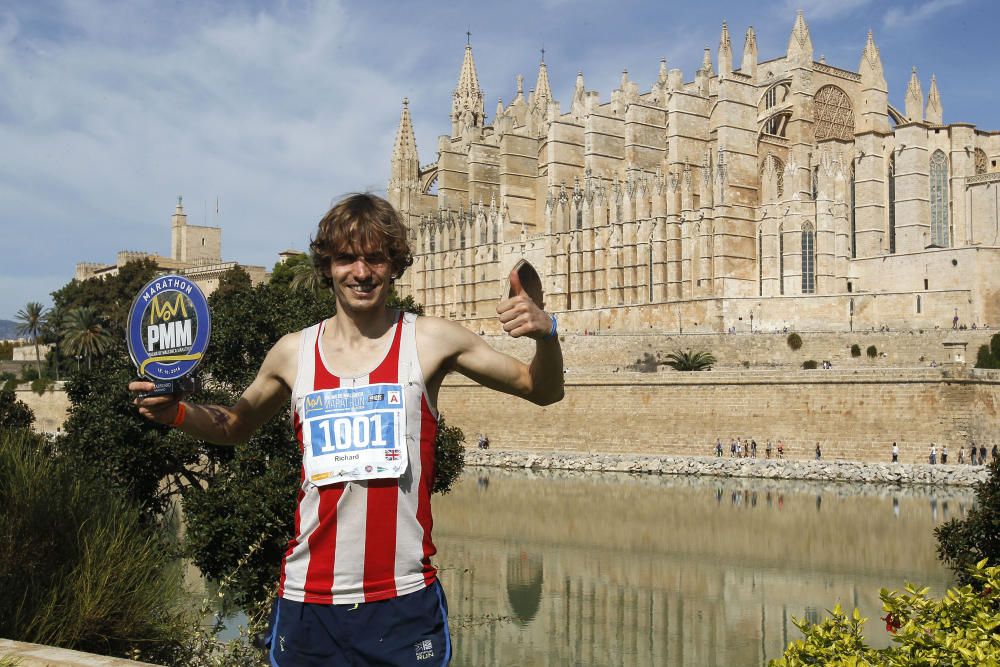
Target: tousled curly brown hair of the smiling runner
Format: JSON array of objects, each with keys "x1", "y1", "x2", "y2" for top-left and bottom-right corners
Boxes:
[{"x1": 309, "y1": 192, "x2": 413, "y2": 288}]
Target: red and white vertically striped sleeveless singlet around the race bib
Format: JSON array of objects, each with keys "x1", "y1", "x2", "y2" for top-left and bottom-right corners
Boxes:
[{"x1": 278, "y1": 313, "x2": 438, "y2": 604}]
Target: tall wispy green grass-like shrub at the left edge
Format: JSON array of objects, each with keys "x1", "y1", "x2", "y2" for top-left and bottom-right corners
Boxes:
[{"x1": 0, "y1": 431, "x2": 188, "y2": 662}]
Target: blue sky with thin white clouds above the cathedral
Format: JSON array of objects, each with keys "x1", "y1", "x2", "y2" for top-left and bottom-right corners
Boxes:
[{"x1": 0, "y1": 0, "x2": 1000, "y2": 319}]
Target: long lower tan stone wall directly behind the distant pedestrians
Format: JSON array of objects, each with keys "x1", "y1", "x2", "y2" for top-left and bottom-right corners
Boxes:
[{"x1": 439, "y1": 368, "x2": 1000, "y2": 463}]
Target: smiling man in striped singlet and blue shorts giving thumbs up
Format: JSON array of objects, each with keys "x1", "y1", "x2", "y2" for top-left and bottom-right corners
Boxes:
[{"x1": 129, "y1": 194, "x2": 563, "y2": 667}]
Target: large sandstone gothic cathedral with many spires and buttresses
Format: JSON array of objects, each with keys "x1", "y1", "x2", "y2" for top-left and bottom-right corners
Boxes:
[{"x1": 388, "y1": 12, "x2": 1000, "y2": 332}]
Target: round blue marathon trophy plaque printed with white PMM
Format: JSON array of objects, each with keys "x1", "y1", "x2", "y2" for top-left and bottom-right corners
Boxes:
[{"x1": 128, "y1": 275, "x2": 212, "y2": 396}]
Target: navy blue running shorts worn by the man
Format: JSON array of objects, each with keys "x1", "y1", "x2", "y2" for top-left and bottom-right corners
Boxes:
[{"x1": 266, "y1": 581, "x2": 451, "y2": 667}]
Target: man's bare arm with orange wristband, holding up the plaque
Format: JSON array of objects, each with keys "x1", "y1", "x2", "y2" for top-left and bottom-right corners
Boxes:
[{"x1": 128, "y1": 333, "x2": 299, "y2": 445}]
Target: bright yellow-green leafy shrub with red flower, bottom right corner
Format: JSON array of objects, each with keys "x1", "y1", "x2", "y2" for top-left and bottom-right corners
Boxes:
[{"x1": 768, "y1": 560, "x2": 1000, "y2": 667}]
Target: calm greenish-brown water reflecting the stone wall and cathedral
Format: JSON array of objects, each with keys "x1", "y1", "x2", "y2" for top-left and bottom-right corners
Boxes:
[{"x1": 434, "y1": 468, "x2": 973, "y2": 667}]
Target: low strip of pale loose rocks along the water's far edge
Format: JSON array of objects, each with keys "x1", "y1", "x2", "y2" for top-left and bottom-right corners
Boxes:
[{"x1": 465, "y1": 449, "x2": 989, "y2": 487}]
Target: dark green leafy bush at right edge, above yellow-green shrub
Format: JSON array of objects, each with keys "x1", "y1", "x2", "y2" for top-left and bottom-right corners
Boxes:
[{"x1": 934, "y1": 459, "x2": 1000, "y2": 584}]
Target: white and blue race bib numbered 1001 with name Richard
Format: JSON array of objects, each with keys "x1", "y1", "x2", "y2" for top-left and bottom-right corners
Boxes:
[{"x1": 301, "y1": 384, "x2": 408, "y2": 486}]
